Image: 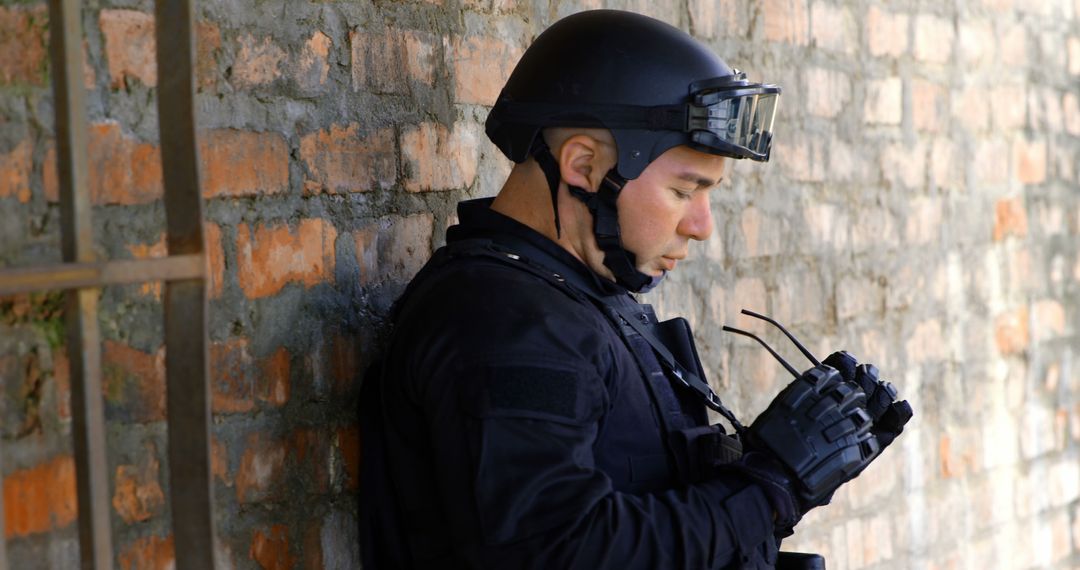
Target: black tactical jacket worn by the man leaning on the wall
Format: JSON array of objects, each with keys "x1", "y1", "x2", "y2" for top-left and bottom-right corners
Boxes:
[{"x1": 365, "y1": 200, "x2": 778, "y2": 569}]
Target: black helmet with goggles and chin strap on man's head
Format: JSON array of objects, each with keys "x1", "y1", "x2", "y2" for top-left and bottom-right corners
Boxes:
[{"x1": 486, "y1": 10, "x2": 780, "y2": 290}]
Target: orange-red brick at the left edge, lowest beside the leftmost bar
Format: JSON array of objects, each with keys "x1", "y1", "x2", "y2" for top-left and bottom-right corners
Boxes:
[{"x1": 3, "y1": 456, "x2": 78, "y2": 539}]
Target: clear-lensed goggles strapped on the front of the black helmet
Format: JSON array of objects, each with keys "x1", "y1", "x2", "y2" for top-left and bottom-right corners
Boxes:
[{"x1": 686, "y1": 70, "x2": 780, "y2": 161}]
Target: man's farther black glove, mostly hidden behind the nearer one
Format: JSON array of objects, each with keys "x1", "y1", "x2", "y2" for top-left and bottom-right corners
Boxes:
[{"x1": 824, "y1": 351, "x2": 914, "y2": 453}]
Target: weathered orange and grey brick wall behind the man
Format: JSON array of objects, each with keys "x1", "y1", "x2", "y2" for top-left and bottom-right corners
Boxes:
[{"x1": 0, "y1": 0, "x2": 1080, "y2": 570}]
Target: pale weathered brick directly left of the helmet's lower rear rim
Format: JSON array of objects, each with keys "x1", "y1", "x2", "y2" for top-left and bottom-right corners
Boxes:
[{"x1": 401, "y1": 121, "x2": 481, "y2": 192}]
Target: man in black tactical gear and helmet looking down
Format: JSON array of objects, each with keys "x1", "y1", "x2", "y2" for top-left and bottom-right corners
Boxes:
[{"x1": 362, "y1": 11, "x2": 909, "y2": 569}]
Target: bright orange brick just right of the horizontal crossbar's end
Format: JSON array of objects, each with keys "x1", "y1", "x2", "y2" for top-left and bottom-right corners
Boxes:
[{"x1": 237, "y1": 218, "x2": 337, "y2": 299}]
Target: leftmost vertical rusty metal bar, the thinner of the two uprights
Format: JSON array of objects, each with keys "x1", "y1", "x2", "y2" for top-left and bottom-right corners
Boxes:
[{"x1": 49, "y1": 0, "x2": 112, "y2": 570}]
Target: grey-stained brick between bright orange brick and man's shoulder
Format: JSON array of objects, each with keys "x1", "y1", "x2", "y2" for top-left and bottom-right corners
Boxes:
[{"x1": 353, "y1": 214, "x2": 434, "y2": 285}]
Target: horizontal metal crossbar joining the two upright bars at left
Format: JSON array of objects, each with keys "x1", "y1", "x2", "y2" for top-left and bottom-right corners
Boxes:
[{"x1": 0, "y1": 255, "x2": 205, "y2": 296}]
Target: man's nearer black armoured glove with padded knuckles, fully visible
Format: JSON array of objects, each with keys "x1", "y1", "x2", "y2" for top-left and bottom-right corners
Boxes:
[{"x1": 732, "y1": 365, "x2": 880, "y2": 535}]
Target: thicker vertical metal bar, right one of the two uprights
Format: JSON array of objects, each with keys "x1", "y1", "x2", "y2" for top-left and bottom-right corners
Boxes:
[{"x1": 154, "y1": 0, "x2": 216, "y2": 570}]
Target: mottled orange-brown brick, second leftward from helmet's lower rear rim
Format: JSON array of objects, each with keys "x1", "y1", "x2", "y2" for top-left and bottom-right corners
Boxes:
[{"x1": 300, "y1": 123, "x2": 397, "y2": 194}]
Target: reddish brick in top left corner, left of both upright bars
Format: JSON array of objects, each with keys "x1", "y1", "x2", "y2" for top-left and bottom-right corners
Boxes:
[{"x1": 0, "y1": 5, "x2": 49, "y2": 85}]
